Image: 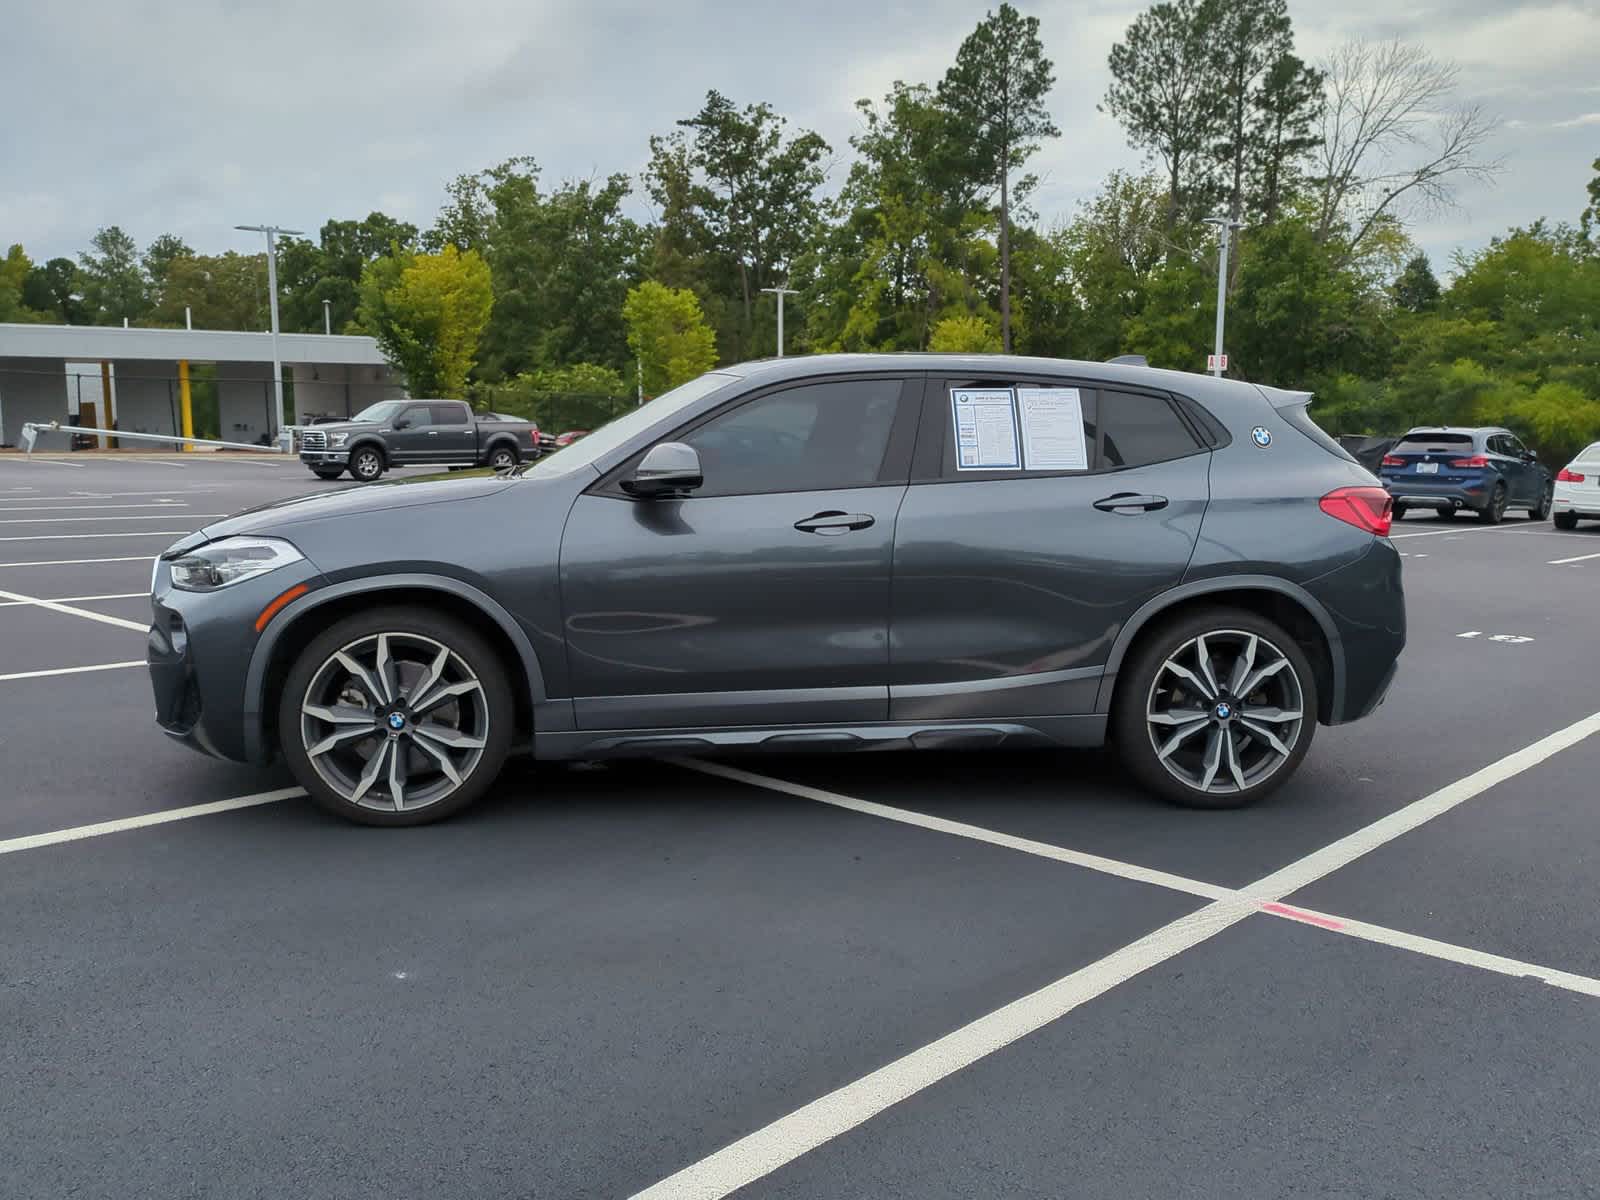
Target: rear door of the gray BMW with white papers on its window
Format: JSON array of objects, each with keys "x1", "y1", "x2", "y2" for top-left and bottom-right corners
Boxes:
[{"x1": 890, "y1": 373, "x2": 1211, "y2": 720}]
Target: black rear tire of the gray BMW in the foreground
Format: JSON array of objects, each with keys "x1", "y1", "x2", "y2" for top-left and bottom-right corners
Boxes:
[{"x1": 1110, "y1": 606, "x2": 1317, "y2": 808}]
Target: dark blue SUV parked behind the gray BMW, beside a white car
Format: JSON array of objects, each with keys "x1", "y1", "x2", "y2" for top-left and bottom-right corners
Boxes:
[{"x1": 1379, "y1": 427, "x2": 1555, "y2": 525}]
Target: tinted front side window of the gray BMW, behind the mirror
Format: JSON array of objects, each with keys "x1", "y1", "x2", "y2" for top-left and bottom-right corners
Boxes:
[{"x1": 682, "y1": 379, "x2": 902, "y2": 496}]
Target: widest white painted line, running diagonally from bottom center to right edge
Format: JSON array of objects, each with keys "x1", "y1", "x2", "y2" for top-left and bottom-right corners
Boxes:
[{"x1": 649, "y1": 712, "x2": 1600, "y2": 1200}]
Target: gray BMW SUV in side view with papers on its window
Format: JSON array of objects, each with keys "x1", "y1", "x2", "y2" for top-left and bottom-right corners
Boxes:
[{"x1": 149, "y1": 355, "x2": 1405, "y2": 826}]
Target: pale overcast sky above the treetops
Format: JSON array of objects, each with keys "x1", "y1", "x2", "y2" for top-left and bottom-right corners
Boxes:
[{"x1": 0, "y1": 0, "x2": 1600, "y2": 270}]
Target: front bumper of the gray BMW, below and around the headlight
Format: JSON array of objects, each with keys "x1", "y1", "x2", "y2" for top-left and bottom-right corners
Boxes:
[{"x1": 146, "y1": 560, "x2": 323, "y2": 762}]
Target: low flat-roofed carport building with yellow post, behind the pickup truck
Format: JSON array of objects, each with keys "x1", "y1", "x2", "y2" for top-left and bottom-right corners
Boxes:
[{"x1": 0, "y1": 323, "x2": 403, "y2": 445}]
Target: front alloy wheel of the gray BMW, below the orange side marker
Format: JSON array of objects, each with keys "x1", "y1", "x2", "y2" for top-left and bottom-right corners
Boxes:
[{"x1": 301, "y1": 632, "x2": 490, "y2": 813}]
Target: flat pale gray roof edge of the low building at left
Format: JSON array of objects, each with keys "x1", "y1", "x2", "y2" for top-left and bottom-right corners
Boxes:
[{"x1": 0, "y1": 323, "x2": 386, "y2": 366}]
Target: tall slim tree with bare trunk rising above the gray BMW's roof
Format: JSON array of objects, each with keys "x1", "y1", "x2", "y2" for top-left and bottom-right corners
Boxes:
[{"x1": 939, "y1": 3, "x2": 1061, "y2": 354}]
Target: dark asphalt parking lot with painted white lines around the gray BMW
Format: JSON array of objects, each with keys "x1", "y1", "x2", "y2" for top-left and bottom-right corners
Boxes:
[{"x1": 0, "y1": 454, "x2": 1600, "y2": 1198}]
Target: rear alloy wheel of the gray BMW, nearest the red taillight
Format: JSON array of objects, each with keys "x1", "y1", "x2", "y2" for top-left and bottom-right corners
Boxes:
[{"x1": 1144, "y1": 629, "x2": 1306, "y2": 795}]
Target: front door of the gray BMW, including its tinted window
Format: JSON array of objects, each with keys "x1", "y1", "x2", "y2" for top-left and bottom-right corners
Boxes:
[{"x1": 562, "y1": 378, "x2": 922, "y2": 730}]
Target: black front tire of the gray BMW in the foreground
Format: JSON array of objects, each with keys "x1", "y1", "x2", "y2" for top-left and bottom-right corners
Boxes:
[{"x1": 278, "y1": 608, "x2": 517, "y2": 826}]
